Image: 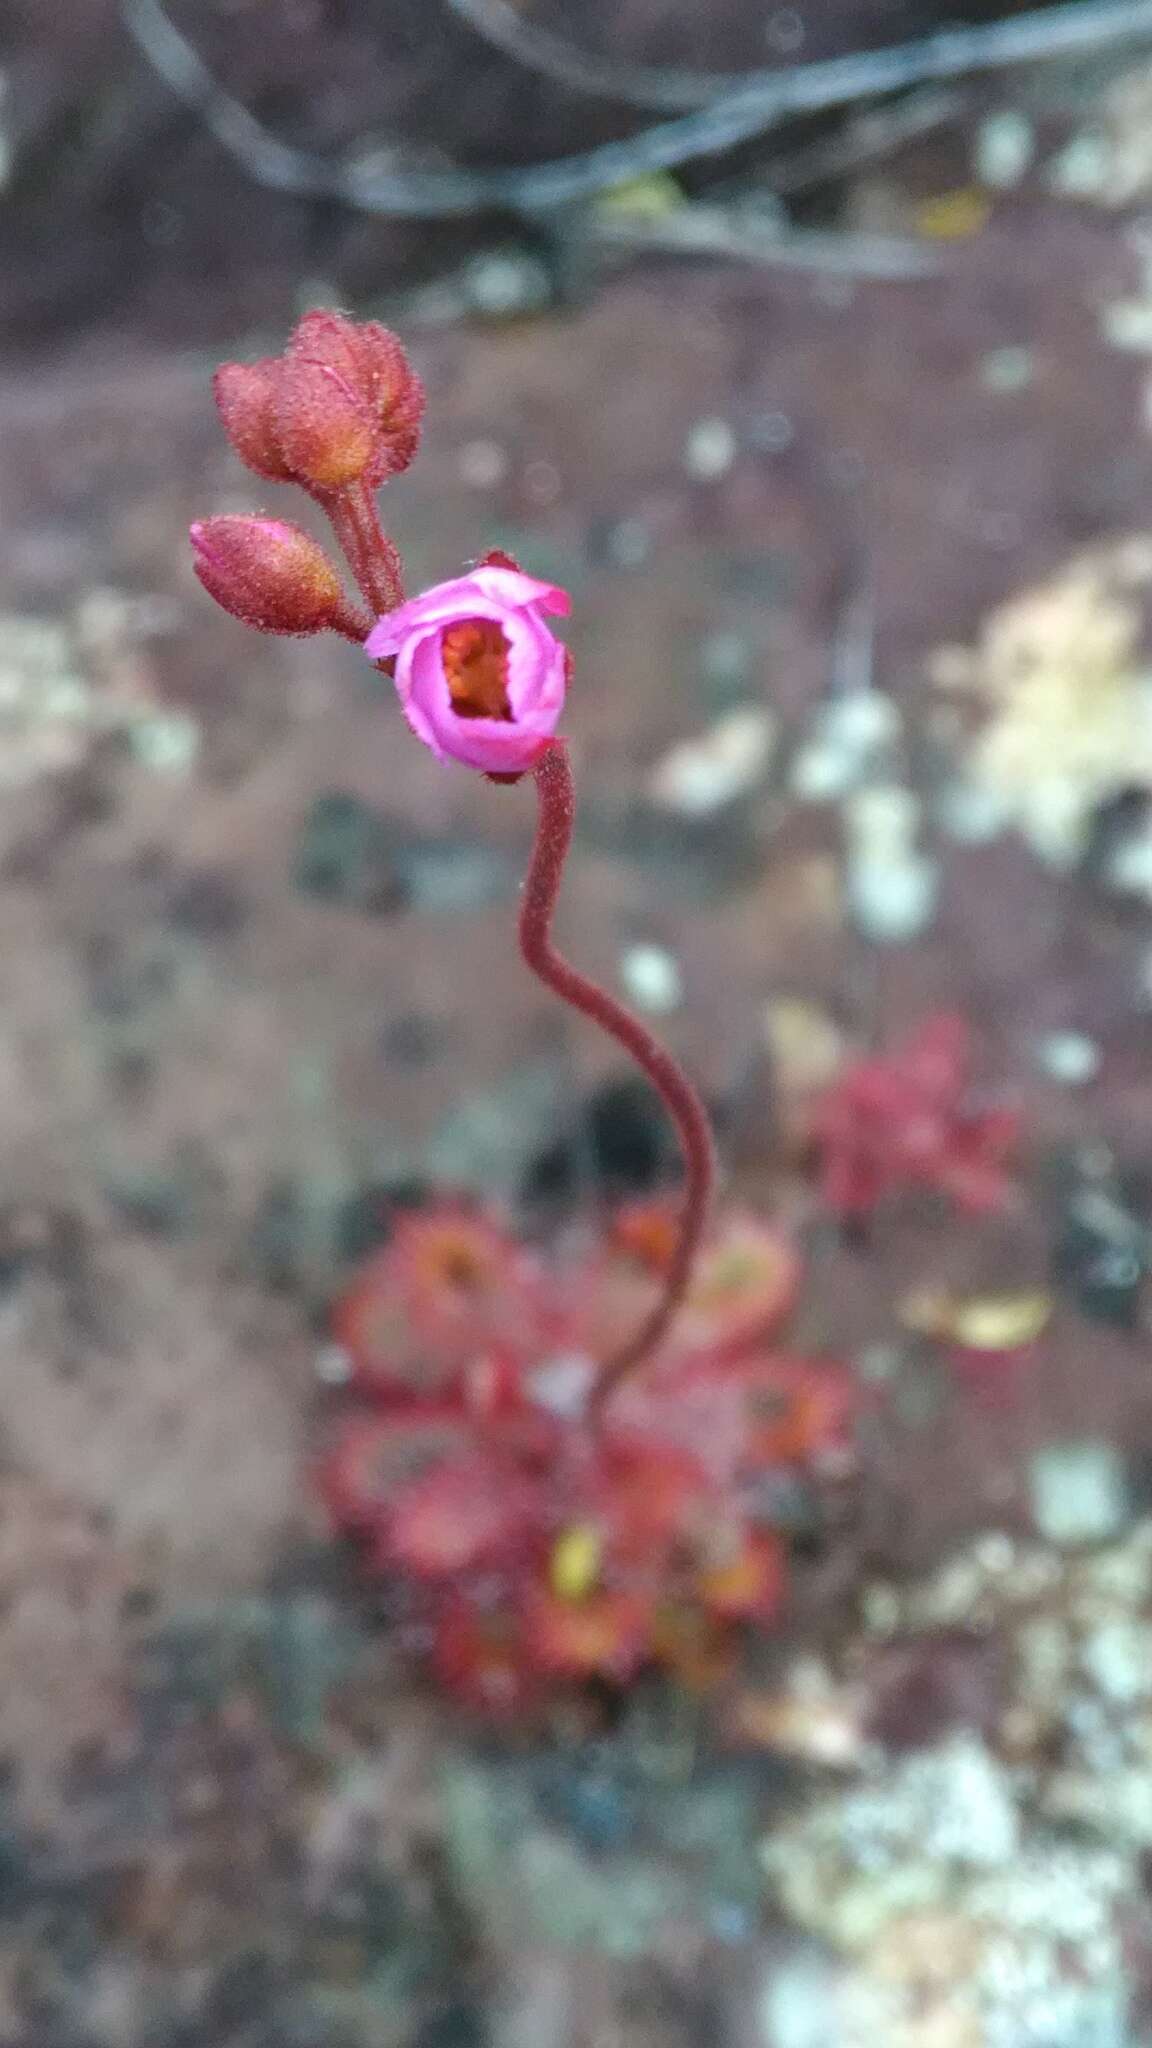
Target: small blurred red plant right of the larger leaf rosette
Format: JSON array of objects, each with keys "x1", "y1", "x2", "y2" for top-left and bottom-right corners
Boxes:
[{"x1": 816, "y1": 1012, "x2": 1021, "y2": 1221}]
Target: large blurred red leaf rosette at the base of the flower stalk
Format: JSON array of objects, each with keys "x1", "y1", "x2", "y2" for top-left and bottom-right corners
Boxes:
[{"x1": 318, "y1": 1202, "x2": 853, "y2": 1714}]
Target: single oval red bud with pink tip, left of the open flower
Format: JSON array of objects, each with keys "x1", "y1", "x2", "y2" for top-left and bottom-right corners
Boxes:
[{"x1": 191, "y1": 518, "x2": 351, "y2": 633}]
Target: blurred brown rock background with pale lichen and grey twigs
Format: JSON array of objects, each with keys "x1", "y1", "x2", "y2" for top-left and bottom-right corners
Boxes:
[{"x1": 0, "y1": 0, "x2": 1152, "y2": 2048}]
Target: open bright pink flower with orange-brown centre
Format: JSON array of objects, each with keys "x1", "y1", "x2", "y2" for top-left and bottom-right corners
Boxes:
[{"x1": 365, "y1": 563, "x2": 570, "y2": 774}]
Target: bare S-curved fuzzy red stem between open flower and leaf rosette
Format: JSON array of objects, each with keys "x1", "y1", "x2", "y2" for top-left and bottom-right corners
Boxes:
[{"x1": 521, "y1": 739, "x2": 715, "y2": 1409}]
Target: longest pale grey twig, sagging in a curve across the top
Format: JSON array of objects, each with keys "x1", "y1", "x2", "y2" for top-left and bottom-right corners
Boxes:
[{"x1": 121, "y1": 0, "x2": 1152, "y2": 219}]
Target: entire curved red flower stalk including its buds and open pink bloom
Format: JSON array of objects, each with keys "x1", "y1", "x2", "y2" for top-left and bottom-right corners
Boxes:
[{"x1": 193, "y1": 311, "x2": 715, "y2": 1419}]
